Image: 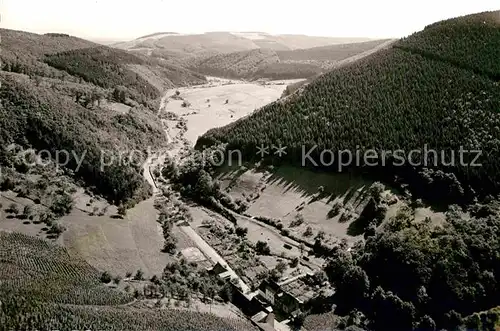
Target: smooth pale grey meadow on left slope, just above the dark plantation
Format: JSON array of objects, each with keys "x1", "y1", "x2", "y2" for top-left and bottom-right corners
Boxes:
[{"x1": 61, "y1": 191, "x2": 171, "y2": 277}]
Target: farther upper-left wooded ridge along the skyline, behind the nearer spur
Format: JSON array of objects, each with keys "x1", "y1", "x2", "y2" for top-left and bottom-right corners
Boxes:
[{"x1": 0, "y1": 29, "x2": 205, "y2": 108}]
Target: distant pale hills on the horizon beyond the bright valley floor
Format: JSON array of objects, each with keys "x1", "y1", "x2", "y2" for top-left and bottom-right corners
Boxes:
[{"x1": 113, "y1": 32, "x2": 385, "y2": 79}]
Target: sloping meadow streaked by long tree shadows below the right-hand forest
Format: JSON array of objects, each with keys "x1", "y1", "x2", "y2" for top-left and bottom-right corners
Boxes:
[{"x1": 218, "y1": 165, "x2": 445, "y2": 249}]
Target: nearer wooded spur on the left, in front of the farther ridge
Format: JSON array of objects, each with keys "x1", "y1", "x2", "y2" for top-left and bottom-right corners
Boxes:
[{"x1": 0, "y1": 73, "x2": 165, "y2": 203}]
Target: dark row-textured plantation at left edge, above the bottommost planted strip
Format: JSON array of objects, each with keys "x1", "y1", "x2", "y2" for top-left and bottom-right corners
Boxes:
[{"x1": 0, "y1": 232, "x2": 132, "y2": 305}]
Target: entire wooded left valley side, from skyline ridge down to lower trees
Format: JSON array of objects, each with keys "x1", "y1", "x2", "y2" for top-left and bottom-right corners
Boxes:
[{"x1": 0, "y1": 29, "x2": 205, "y2": 203}]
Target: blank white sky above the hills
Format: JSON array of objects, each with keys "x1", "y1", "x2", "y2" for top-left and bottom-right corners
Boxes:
[{"x1": 0, "y1": 0, "x2": 500, "y2": 39}]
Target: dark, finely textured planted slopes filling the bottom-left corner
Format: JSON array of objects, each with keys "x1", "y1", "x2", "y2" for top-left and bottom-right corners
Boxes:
[{"x1": 0, "y1": 233, "x2": 255, "y2": 331}]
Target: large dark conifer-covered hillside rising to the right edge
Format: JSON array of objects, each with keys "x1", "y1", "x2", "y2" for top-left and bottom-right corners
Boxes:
[{"x1": 198, "y1": 12, "x2": 500, "y2": 203}]
